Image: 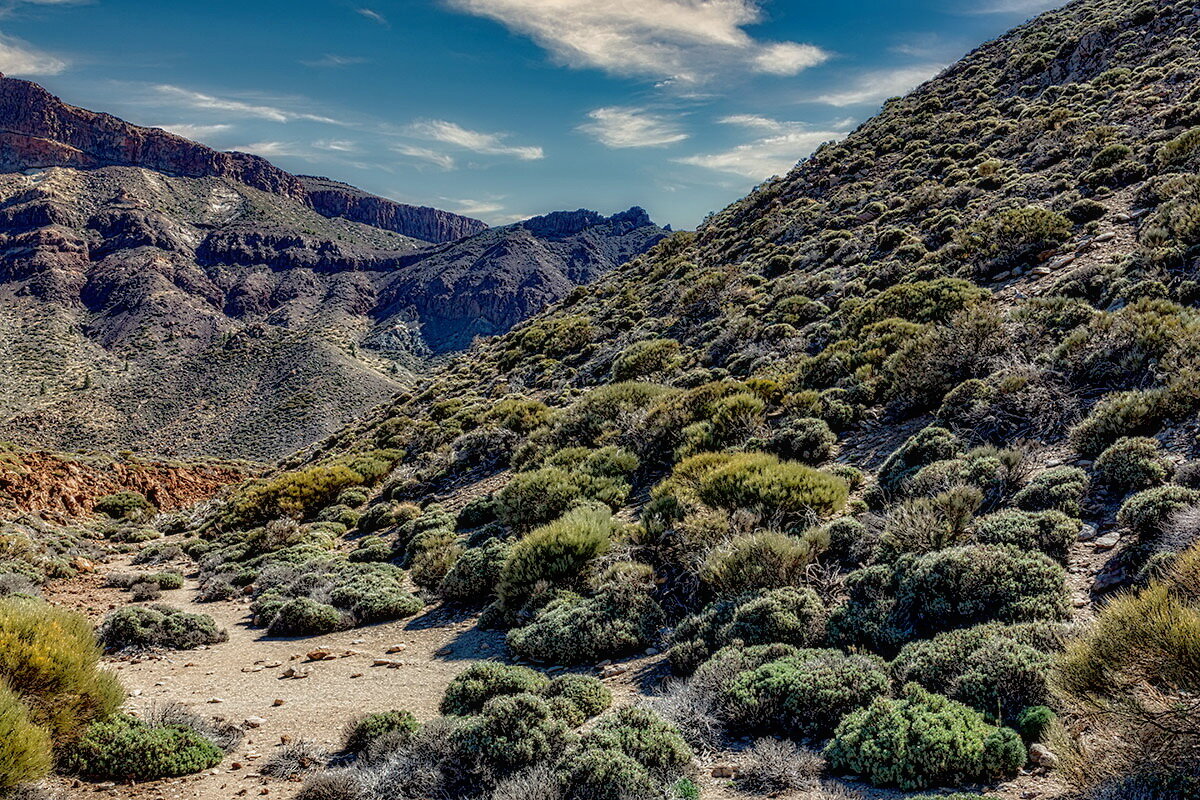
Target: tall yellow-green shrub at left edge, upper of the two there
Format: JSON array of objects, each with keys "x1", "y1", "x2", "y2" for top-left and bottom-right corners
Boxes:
[{"x1": 0, "y1": 597, "x2": 125, "y2": 744}]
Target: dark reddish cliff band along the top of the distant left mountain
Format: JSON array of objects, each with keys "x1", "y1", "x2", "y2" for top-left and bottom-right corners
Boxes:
[{"x1": 0, "y1": 76, "x2": 487, "y2": 243}]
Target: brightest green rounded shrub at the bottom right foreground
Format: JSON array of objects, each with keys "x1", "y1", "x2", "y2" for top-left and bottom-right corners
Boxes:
[{"x1": 826, "y1": 684, "x2": 1026, "y2": 789}]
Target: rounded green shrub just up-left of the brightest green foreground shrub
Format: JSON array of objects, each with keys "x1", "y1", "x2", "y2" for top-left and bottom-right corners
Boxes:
[{"x1": 726, "y1": 650, "x2": 892, "y2": 739}]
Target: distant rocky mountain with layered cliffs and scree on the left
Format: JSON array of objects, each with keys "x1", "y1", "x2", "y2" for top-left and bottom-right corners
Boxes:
[{"x1": 0, "y1": 79, "x2": 664, "y2": 459}]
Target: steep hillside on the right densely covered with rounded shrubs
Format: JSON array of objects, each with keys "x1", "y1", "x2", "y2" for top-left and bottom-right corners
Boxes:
[{"x1": 14, "y1": 0, "x2": 1200, "y2": 800}]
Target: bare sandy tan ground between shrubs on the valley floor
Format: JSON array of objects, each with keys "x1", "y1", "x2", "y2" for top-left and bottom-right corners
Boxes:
[{"x1": 39, "y1": 543, "x2": 1092, "y2": 800}]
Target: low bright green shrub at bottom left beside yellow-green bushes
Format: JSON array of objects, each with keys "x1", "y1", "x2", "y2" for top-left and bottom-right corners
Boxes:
[{"x1": 64, "y1": 714, "x2": 224, "y2": 781}]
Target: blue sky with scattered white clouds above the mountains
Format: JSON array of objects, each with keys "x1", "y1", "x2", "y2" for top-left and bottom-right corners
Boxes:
[{"x1": 0, "y1": 0, "x2": 1057, "y2": 228}]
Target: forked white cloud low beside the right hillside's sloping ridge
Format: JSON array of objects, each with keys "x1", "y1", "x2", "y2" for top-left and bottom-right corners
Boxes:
[{"x1": 676, "y1": 114, "x2": 846, "y2": 181}]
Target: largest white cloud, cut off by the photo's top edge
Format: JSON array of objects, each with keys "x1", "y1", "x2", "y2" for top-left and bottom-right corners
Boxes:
[{"x1": 445, "y1": 0, "x2": 828, "y2": 83}]
